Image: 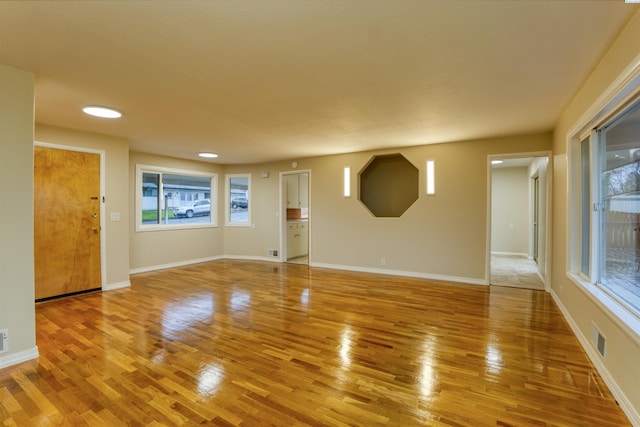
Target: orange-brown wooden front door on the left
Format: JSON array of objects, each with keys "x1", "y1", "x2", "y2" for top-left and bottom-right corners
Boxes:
[{"x1": 34, "y1": 147, "x2": 102, "y2": 300}]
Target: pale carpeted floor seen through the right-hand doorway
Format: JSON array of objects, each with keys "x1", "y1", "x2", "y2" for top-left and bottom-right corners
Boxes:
[{"x1": 491, "y1": 255, "x2": 544, "y2": 290}]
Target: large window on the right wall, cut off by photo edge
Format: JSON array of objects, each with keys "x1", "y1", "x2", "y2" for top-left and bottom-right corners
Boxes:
[{"x1": 573, "y1": 101, "x2": 640, "y2": 318}]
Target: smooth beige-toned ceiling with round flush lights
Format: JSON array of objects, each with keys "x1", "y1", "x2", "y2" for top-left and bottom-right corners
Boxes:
[{"x1": 0, "y1": 0, "x2": 638, "y2": 164}]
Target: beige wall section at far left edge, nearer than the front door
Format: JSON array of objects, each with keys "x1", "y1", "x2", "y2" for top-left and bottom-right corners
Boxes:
[{"x1": 0, "y1": 65, "x2": 38, "y2": 368}]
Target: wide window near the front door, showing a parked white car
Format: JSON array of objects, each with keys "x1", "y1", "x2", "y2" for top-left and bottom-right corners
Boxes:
[{"x1": 136, "y1": 165, "x2": 217, "y2": 231}]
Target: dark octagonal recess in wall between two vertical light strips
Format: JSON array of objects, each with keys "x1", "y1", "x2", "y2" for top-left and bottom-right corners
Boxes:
[{"x1": 358, "y1": 154, "x2": 419, "y2": 217}]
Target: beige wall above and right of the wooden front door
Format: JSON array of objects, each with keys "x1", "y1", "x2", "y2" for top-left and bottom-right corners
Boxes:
[{"x1": 35, "y1": 124, "x2": 130, "y2": 289}]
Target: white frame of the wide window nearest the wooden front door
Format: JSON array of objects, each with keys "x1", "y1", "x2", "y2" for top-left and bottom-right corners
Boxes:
[{"x1": 135, "y1": 164, "x2": 218, "y2": 232}]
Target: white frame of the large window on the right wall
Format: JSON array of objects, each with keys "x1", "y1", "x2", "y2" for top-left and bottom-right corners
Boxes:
[{"x1": 560, "y1": 55, "x2": 640, "y2": 344}]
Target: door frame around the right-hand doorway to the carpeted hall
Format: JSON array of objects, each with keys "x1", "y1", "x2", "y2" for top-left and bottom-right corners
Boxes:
[{"x1": 485, "y1": 151, "x2": 553, "y2": 292}]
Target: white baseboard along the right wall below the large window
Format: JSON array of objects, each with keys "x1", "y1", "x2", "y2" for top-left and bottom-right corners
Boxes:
[{"x1": 550, "y1": 289, "x2": 640, "y2": 427}]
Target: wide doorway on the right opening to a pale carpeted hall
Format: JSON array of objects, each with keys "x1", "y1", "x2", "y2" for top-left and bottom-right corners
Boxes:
[{"x1": 487, "y1": 155, "x2": 550, "y2": 290}]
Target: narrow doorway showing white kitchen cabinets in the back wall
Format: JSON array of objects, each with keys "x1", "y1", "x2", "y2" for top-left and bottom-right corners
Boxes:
[{"x1": 280, "y1": 171, "x2": 311, "y2": 265}]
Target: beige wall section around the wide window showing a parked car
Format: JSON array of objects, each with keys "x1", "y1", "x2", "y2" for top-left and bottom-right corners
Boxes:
[{"x1": 124, "y1": 152, "x2": 224, "y2": 271}]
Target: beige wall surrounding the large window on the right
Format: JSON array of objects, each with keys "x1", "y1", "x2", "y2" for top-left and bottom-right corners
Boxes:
[{"x1": 551, "y1": 9, "x2": 640, "y2": 425}]
